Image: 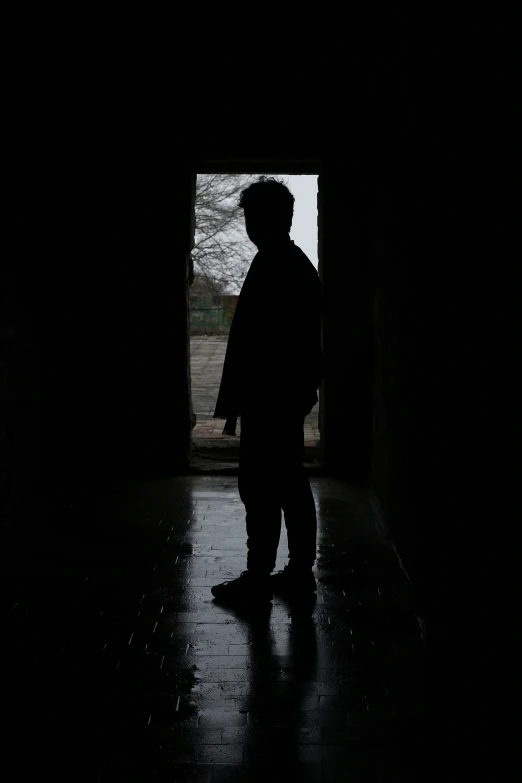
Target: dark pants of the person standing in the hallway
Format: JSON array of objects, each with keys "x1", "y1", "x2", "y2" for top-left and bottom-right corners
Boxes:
[{"x1": 238, "y1": 412, "x2": 317, "y2": 575}]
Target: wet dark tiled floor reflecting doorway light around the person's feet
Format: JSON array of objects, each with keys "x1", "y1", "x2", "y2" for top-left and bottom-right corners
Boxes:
[{"x1": 5, "y1": 476, "x2": 424, "y2": 783}]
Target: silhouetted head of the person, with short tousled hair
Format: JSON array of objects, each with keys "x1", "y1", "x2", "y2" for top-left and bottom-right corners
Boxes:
[{"x1": 239, "y1": 177, "x2": 295, "y2": 248}]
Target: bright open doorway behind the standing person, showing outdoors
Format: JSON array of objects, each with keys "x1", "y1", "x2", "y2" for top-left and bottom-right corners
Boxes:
[{"x1": 188, "y1": 161, "x2": 323, "y2": 472}]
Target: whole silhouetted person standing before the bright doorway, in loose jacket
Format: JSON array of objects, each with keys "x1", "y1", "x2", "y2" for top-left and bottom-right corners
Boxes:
[{"x1": 212, "y1": 177, "x2": 322, "y2": 603}]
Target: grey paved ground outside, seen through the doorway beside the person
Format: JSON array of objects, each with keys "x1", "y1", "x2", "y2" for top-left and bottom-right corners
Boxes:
[{"x1": 190, "y1": 336, "x2": 320, "y2": 449}]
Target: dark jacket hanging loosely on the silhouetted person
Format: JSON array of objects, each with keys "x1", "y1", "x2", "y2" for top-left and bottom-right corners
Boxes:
[{"x1": 214, "y1": 240, "x2": 322, "y2": 419}]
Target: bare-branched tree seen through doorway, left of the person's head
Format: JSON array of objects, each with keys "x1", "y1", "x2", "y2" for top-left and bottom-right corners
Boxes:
[{"x1": 190, "y1": 174, "x2": 255, "y2": 295}]
